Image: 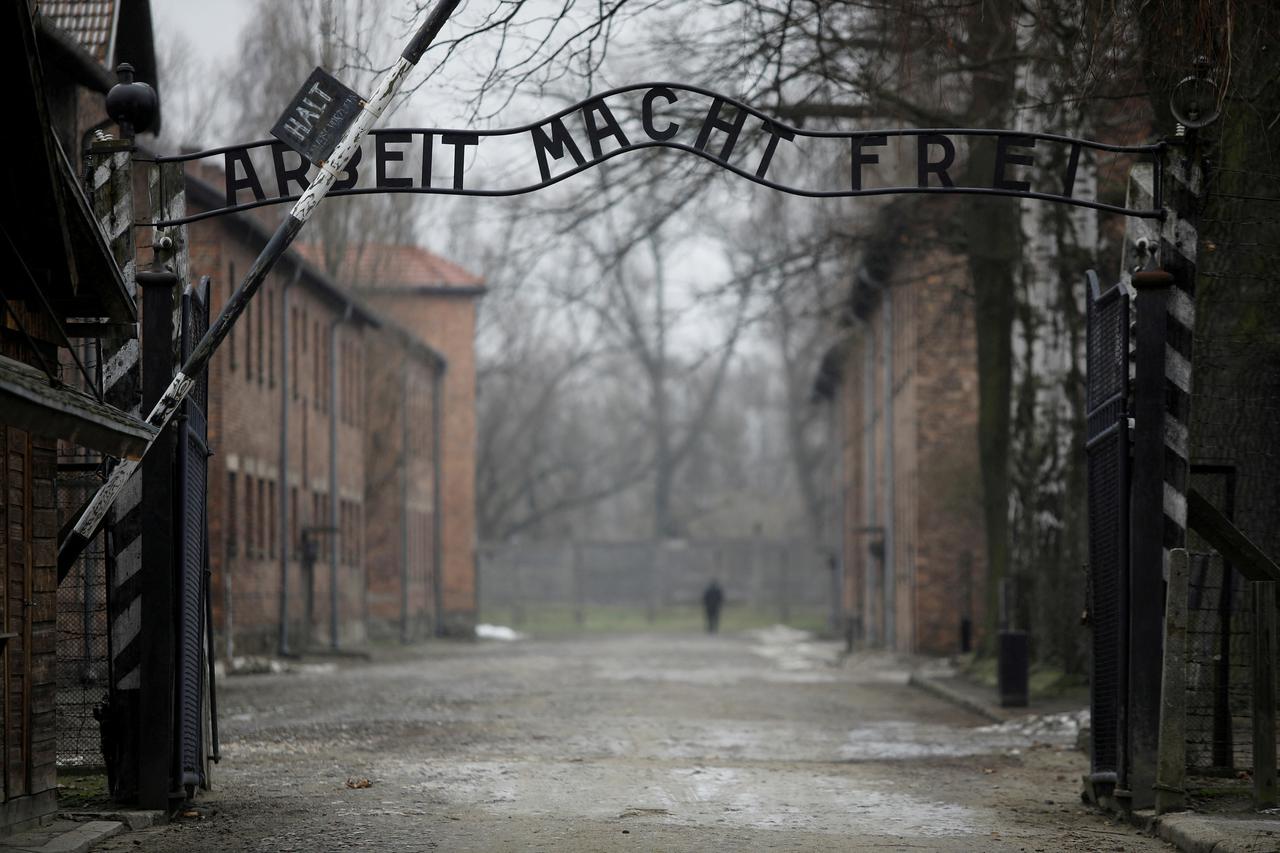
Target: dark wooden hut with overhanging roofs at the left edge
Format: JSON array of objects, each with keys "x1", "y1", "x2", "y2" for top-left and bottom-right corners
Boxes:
[{"x1": 0, "y1": 0, "x2": 152, "y2": 834}]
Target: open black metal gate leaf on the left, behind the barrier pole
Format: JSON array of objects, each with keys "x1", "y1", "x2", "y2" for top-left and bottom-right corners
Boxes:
[{"x1": 174, "y1": 277, "x2": 209, "y2": 790}]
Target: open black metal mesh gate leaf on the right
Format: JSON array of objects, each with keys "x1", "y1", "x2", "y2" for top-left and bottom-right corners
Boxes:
[{"x1": 1084, "y1": 270, "x2": 1129, "y2": 784}]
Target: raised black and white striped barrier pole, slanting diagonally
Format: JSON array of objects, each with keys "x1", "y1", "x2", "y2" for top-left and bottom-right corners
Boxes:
[{"x1": 58, "y1": 0, "x2": 461, "y2": 571}]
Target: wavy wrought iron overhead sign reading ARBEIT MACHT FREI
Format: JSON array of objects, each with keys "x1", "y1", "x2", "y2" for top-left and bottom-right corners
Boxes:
[{"x1": 154, "y1": 81, "x2": 1162, "y2": 225}]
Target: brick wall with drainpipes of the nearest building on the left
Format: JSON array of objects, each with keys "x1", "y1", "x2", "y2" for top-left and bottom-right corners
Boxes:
[{"x1": 188, "y1": 201, "x2": 369, "y2": 653}]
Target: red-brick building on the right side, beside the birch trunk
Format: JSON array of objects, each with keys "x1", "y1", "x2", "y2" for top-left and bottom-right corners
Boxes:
[{"x1": 815, "y1": 204, "x2": 986, "y2": 653}]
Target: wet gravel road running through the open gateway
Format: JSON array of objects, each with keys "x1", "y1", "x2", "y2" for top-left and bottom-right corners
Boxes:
[{"x1": 96, "y1": 628, "x2": 1172, "y2": 853}]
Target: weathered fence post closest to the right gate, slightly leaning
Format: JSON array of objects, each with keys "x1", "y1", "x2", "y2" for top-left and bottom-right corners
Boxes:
[{"x1": 1156, "y1": 548, "x2": 1187, "y2": 815}]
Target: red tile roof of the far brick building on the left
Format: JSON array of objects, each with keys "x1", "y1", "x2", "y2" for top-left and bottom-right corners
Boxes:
[{"x1": 294, "y1": 243, "x2": 484, "y2": 289}]
